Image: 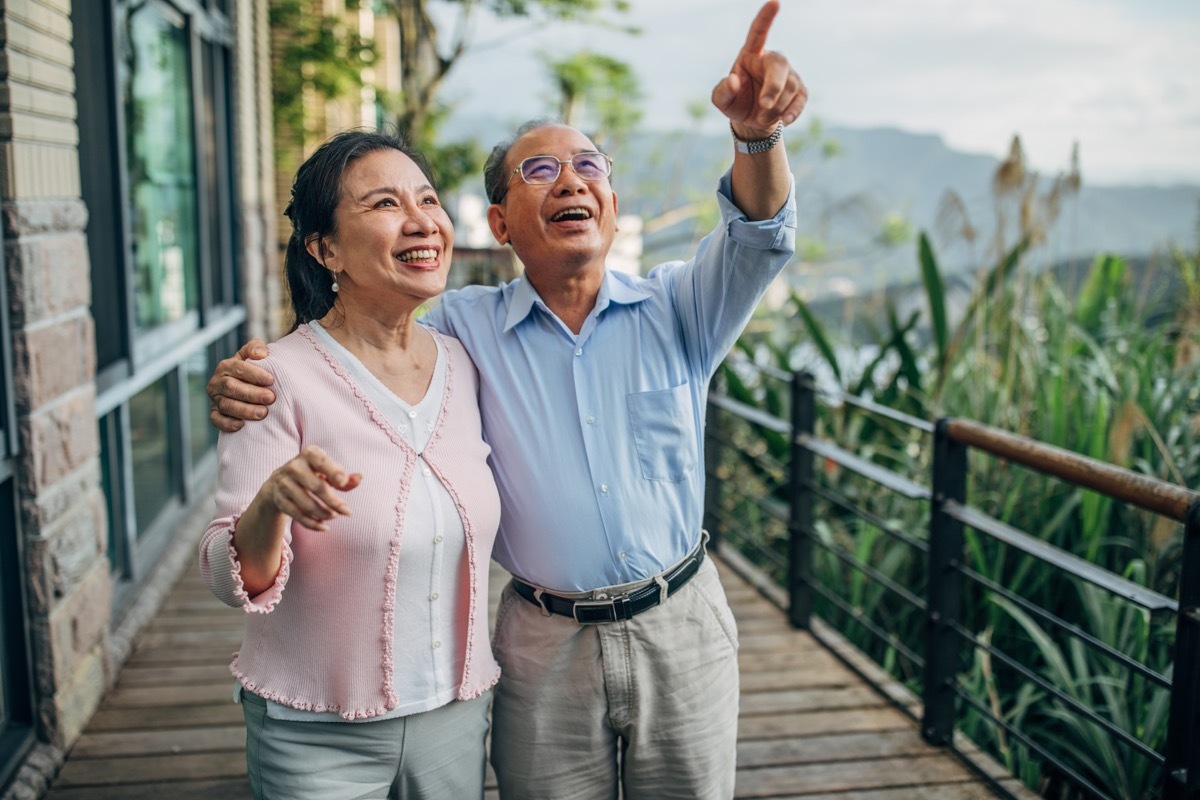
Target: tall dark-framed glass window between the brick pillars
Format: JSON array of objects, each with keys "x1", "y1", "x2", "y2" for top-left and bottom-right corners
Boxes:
[{"x1": 72, "y1": 0, "x2": 245, "y2": 615}]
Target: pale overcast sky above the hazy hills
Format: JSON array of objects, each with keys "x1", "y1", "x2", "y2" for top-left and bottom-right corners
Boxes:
[{"x1": 445, "y1": 0, "x2": 1200, "y2": 184}]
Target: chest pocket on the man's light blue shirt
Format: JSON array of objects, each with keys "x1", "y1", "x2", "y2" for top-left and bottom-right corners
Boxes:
[{"x1": 625, "y1": 384, "x2": 697, "y2": 482}]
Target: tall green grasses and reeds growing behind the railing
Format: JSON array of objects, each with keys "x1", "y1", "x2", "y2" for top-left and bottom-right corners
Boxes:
[{"x1": 719, "y1": 226, "x2": 1200, "y2": 800}]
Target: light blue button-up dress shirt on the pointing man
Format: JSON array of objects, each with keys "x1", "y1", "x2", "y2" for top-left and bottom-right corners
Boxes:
[{"x1": 421, "y1": 173, "x2": 796, "y2": 591}]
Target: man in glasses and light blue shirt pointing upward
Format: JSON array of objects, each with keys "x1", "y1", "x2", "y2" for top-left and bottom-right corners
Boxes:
[{"x1": 209, "y1": 0, "x2": 806, "y2": 800}]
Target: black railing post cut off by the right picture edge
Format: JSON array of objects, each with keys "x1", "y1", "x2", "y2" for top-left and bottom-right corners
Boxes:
[{"x1": 1163, "y1": 501, "x2": 1200, "y2": 800}]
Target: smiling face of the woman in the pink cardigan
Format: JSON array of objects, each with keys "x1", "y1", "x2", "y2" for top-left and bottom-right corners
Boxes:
[{"x1": 308, "y1": 149, "x2": 454, "y2": 312}]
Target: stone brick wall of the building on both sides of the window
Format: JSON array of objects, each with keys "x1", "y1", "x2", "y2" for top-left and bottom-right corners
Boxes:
[{"x1": 0, "y1": 0, "x2": 281, "y2": 800}]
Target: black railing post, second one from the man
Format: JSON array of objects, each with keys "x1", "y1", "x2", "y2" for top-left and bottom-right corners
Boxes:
[{"x1": 787, "y1": 372, "x2": 816, "y2": 628}]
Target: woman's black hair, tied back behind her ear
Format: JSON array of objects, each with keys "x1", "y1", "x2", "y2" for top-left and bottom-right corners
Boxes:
[{"x1": 283, "y1": 130, "x2": 437, "y2": 330}]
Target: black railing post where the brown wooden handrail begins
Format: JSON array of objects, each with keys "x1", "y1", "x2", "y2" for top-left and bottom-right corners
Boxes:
[{"x1": 920, "y1": 419, "x2": 967, "y2": 746}]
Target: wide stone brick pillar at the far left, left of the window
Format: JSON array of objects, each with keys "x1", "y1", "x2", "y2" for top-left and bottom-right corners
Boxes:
[{"x1": 0, "y1": 0, "x2": 112, "y2": 762}]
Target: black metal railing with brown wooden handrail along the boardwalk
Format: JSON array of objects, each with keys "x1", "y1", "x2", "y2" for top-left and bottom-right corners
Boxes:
[{"x1": 706, "y1": 362, "x2": 1200, "y2": 800}]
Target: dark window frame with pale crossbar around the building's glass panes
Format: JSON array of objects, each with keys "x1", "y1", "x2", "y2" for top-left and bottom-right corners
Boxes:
[{"x1": 73, "y1": 0, "x2": 246, "y2": 619}]
